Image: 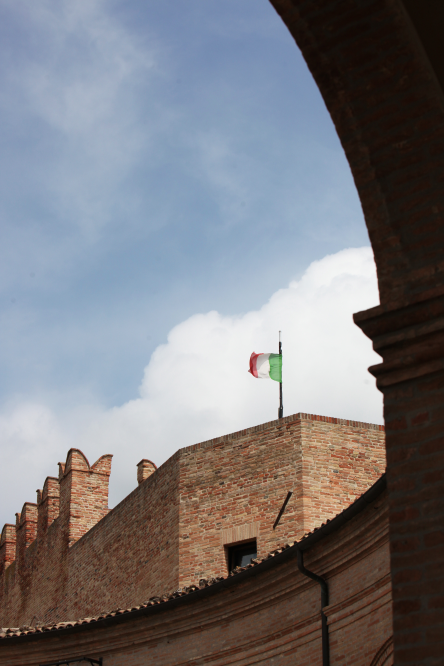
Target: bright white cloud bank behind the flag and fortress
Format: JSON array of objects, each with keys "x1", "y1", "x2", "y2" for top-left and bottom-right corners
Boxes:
[{"x1": 0, "y1": 248, "x2": 382, "y2": 521}]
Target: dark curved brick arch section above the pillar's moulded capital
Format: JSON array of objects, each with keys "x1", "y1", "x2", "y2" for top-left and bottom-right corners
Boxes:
[{"x1": 272, "y1": 0, "x2": 444, "y2": 305}]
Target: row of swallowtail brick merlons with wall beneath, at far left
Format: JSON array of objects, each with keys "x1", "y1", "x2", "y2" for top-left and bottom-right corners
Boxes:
[{"x1": 0, "y1": 449, "x2": 112, "y2": 622}]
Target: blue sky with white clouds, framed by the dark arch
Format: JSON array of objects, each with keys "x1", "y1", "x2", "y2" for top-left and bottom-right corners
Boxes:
[{"x1": 0, "y1": 0, "x2": 382, "y2": 524}]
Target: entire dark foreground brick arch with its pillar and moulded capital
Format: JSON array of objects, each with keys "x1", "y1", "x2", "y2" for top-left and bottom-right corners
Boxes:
[{"x1": 270, "y1": 0, "x2": 444, "y2": 664}]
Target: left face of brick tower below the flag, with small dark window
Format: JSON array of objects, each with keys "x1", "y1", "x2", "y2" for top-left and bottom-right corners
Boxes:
[{"x1": 179, "y1": 417, "x2": 302, "y2": 586}]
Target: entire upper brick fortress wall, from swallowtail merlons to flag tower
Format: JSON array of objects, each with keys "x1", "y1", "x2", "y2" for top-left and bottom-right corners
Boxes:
[{"x1": 0, "y1": 414, "x2": 385, "y2": 626}]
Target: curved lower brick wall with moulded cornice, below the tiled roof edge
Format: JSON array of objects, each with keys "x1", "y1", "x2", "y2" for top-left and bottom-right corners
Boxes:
[{"x1": 0, "y1": 486, "x2": 393, "y2": 666}]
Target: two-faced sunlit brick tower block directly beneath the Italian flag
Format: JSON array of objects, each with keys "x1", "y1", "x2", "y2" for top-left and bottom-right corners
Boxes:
[{"x1": 179, "y1": 414, "x2": 385, "y2": 585}]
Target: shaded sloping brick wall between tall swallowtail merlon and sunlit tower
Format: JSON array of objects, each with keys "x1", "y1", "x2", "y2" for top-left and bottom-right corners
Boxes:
[{"x1": 59, "y1": 446, "x2": 179, "y2": 620}]
